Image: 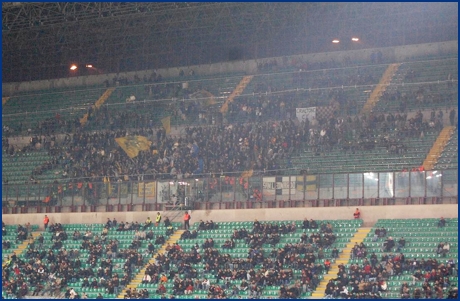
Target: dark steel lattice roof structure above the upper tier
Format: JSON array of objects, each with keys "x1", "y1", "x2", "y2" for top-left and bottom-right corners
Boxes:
[{"x1": 2, "y1": 2, "x2": 458, "y2": 81}]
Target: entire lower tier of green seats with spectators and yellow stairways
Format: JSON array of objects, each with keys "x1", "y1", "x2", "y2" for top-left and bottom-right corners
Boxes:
[{"x1": 2, "y1": 218, "x2": 458, "y2": 299}]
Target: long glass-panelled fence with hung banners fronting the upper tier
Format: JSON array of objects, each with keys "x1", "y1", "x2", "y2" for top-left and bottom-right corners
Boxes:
[{"x1": 2, "y1": 169, "x2": 458, "y2": 214}]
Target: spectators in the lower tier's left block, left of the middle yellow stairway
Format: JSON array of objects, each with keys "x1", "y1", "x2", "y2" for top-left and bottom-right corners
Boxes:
[{"x1": 2, "y1": 219, "x2": 173, "y2": 299}]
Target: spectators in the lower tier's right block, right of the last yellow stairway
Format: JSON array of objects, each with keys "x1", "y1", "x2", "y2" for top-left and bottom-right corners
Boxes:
[{"x1": 325, "y1": 220, "x2": 458, "y2": 299}]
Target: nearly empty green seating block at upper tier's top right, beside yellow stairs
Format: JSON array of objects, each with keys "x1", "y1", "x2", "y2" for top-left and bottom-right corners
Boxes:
[{"x1": 374, "y1": 58, "x2": 458, "y2": 112}]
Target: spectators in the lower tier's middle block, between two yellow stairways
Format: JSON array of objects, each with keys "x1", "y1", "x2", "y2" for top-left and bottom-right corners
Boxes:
[{"x1": 126, "y1": 220, "x2": 337, "y2": 299}]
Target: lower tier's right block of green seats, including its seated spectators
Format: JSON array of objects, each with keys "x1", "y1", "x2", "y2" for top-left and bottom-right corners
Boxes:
[{"x1": 325, "y1": 219, "x2": 458, "y2": 299}]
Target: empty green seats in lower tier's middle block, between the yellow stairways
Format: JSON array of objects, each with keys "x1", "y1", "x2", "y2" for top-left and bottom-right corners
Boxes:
[{"x1": 131, "y1": 220, "x2": 362, "y2": 299}]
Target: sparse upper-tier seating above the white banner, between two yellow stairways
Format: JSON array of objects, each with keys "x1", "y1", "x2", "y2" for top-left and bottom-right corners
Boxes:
[{"x1": 227, "y1": 65, "x2": 386, "y2": 122}]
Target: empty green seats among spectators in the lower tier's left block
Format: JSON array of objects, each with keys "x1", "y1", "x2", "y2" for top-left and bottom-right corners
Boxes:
[{"x1": 2, "y1": 219, "x2": 180, "y2": 299}]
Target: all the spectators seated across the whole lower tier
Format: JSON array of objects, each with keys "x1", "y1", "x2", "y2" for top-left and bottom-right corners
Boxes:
[{"x1": 2, "y1": 214, "x2": 458, "y2": 299}]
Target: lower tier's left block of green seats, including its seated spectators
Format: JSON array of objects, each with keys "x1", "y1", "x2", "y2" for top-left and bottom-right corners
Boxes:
[{"x1": 2, "y1": 219, "x2": 180, "y2": 299}]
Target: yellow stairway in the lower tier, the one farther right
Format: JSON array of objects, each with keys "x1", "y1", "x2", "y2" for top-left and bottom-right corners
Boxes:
[{"x1": 311, "y1": 227, "x2": 372, "y2": 299}]
